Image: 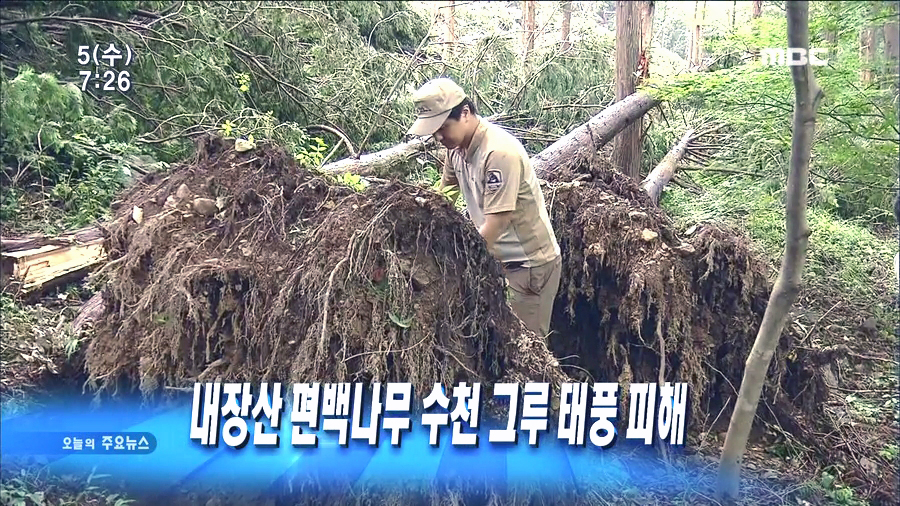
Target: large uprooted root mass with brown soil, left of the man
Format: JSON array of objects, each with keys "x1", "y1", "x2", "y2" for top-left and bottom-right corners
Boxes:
[{"x1": 86, "y1": 137, "x2": 566, "y2": 404}]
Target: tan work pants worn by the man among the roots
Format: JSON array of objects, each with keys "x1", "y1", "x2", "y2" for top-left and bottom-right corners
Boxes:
[{"x1": 503, "y1": 257, "x2": 562, "y2": 336}]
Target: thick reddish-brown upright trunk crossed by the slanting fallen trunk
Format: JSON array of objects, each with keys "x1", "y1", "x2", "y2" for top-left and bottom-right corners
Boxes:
[{"x1": 613, "y1": 0, "x2": 641, "y2": 181}]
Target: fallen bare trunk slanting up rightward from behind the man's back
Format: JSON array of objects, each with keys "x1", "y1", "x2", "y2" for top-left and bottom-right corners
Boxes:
[{"x1": 531, "y1": 92, "x2": 660, "y2": 178}]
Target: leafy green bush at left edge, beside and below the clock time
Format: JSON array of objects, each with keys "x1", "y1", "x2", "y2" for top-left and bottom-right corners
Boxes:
[{"x1": 0, "y1": 67, "x2": 141, "y2": 228}]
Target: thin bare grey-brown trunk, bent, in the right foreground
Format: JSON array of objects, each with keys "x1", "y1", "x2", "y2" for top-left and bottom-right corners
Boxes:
[{"x1": 717, "y1": 1, "x2": 822, "y2": 500}]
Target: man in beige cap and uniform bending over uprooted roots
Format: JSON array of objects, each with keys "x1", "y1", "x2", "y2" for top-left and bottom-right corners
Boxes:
[{"x1": 408, "y1": 78, "x2": 562, "y2": 336}]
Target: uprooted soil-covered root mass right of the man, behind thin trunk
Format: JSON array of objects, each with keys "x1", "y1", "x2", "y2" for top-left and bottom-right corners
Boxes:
[{"x1": 545, "y1": 161, "x2": 827, "y2": 450}]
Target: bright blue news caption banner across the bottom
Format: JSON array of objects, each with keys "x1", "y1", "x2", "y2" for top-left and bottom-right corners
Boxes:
[{"x1": 0, "y1": 386, "x2": 701, "y2": 494}]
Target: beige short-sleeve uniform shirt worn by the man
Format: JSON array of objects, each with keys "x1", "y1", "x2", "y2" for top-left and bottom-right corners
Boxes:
[{"x1": 444, "y1": 116, "x2": 560, "y2": 267}]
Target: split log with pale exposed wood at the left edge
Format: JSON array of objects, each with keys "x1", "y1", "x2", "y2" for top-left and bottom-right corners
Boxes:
[{"x1": 0, "y1": 227, "x2": 106, "y2": 294}]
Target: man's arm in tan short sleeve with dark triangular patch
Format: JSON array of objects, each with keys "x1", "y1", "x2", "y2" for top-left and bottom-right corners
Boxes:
[{"x1": 478, "y1": 151, "x2": 522, "y2": 251}]
